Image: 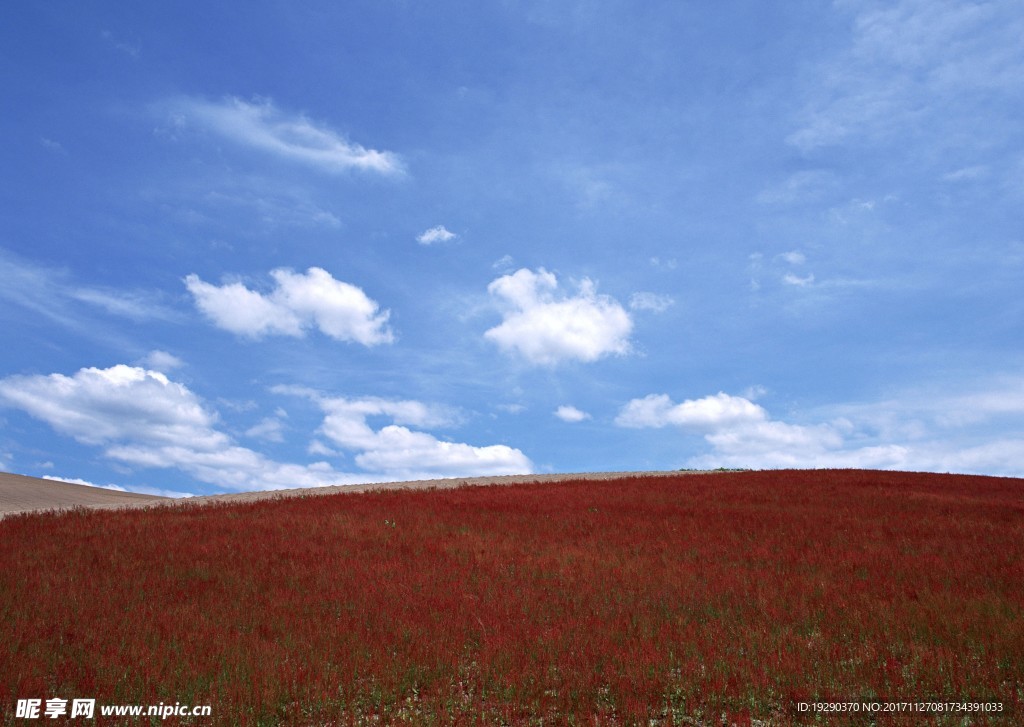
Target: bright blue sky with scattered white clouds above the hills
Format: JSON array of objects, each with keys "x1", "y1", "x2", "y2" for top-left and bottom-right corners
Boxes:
[{"x1": 0, "y1": 0, "x2": 1024, "y2": 494}]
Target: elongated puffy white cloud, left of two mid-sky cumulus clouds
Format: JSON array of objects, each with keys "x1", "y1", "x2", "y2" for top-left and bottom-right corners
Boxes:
[{"x1": 185, "y1": 267, "x2": 394, "y2": 346}]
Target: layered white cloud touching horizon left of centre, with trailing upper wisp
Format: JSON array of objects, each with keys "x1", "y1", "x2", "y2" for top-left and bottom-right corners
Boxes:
[{"x1": 275, "y1": 387, "x2": 534, "y2": 479}]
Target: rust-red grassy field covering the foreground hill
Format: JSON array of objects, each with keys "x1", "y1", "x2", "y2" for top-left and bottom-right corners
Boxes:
[{"x1": 0, "y1": 470, "x2": 1024, "y2": 725}]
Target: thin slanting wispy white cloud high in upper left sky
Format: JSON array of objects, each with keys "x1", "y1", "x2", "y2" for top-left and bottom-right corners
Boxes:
[{"x1": 170, "y1": 97, "x2": 403, "y2": 175}]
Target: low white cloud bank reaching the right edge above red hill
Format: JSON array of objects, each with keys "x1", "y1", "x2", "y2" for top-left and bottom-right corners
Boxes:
[{"x1": 615, "y1": 380, "x2": 1024, "y2": 476}]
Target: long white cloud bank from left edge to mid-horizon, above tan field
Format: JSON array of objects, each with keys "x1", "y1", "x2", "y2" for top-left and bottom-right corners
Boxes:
[{"x1": 0, "y1": 365, "x2": 534, "y2": 490}]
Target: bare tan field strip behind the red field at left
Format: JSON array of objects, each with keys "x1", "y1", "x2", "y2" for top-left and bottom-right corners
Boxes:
[{"x1": 0, "y1": 471, "x2": 680, "y2": 518}]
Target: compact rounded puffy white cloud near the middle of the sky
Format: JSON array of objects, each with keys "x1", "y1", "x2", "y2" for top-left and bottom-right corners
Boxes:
[{"x1": 484, "y1": 267, "x2": 633, "y2": 366}]
